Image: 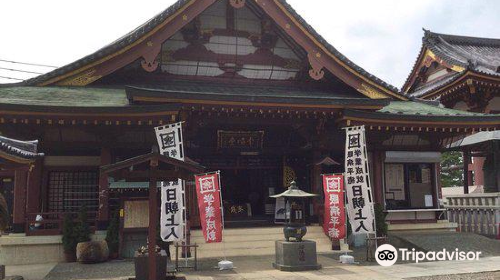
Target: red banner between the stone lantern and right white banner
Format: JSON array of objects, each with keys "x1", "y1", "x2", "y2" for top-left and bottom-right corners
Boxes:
[{"x1": 323, "y1": 175, "x2": 346, "y2": 239}]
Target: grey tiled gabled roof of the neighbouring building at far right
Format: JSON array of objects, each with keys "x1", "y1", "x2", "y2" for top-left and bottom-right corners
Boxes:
[{"x1": 402, "y1": 29, "x2": 500, "y2": 97}]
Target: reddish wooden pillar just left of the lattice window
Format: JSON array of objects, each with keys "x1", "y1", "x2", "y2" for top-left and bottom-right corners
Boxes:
[{"x1": 26, "y1": 158, "x2": 43, "y2": 214}]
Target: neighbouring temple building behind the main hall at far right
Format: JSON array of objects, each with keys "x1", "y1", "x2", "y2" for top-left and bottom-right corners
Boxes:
[{"x1": 402, "y1": 30, "x2": 500, "y2": 192}]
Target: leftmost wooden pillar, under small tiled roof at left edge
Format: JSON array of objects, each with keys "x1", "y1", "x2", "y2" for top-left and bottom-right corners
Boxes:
[{"x1": 12, "y1": 168, "x2": 28, "y2": 233}]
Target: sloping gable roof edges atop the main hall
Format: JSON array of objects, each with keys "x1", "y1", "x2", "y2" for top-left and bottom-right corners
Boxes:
[{"x1": 19, "y1": 0, "x2": 406, "y2": 100}]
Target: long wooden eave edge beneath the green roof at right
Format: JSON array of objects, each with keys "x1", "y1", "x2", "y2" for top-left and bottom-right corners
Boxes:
[{"x1": 339, "y1": 110, "x2": 500, "y2": 128}]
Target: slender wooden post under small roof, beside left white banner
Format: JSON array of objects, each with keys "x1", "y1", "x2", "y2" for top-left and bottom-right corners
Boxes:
[{"x1": 148, "y1": 160, "x2": 157, "y2": 280}]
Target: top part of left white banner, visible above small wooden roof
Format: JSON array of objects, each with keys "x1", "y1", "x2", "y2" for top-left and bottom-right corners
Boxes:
[{"x1": 155, "y1": 122, "x2": 184, "y2": 160}]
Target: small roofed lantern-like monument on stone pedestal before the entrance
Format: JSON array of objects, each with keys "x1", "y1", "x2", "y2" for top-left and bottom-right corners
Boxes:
[{"x1": 271, "y1": 181, "x2": 321, "y2": 271}]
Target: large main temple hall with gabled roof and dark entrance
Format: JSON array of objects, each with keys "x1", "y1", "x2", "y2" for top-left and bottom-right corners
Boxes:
[{"x1": 0, "y1": 0, "x2": 500, "y2": 262}]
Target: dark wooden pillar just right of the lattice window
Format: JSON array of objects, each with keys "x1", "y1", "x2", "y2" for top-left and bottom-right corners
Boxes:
[{"x1": 97, "y1": 147, "x2": 111, "y2": 230}]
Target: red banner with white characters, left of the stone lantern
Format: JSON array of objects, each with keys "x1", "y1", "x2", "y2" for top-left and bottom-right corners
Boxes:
[{"x1": 195, "y1": 173, "x2": 222, "y2": 243}]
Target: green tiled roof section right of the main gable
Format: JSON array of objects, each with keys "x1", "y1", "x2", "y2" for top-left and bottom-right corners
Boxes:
[{"x1": 378, "y1": 101, "x2": 484, "y2": 116}]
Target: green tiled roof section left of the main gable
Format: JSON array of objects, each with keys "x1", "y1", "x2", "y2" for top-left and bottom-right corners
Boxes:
[{"x1": 0, "y1": 86, "x2": 128, "y2": 107}]
